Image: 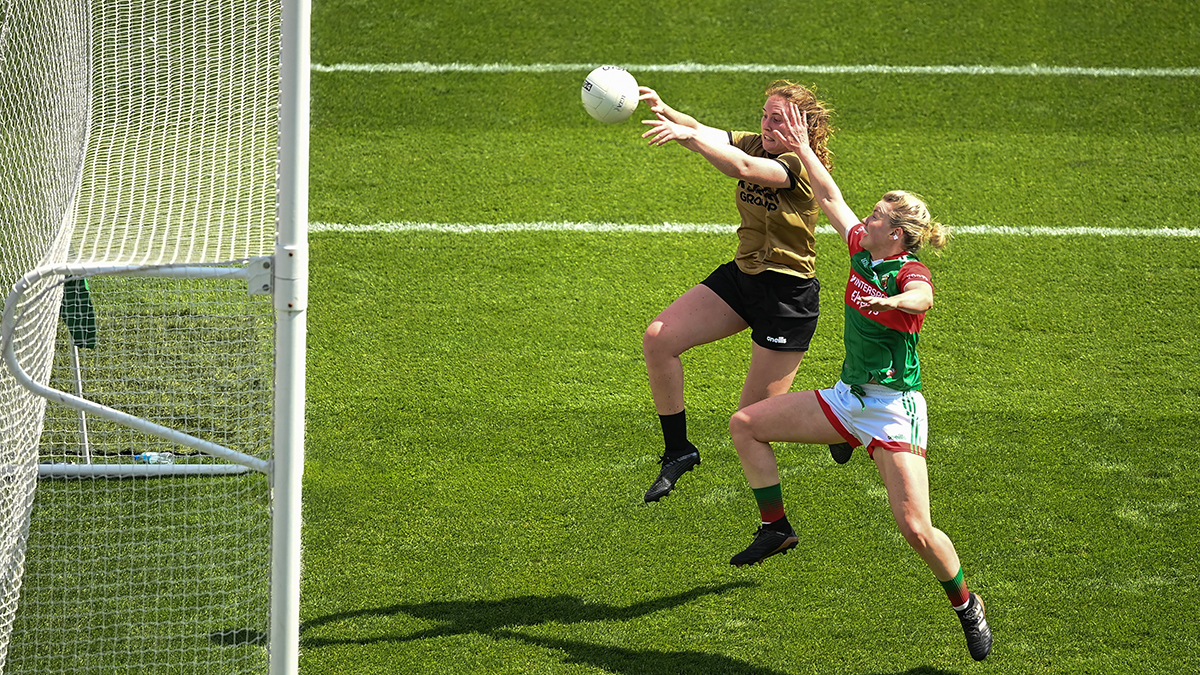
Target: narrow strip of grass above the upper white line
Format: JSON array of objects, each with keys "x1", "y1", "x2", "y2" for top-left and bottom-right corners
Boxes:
[{"x1": 313, "y1": 0, "x2": 1200, "y2": 67}]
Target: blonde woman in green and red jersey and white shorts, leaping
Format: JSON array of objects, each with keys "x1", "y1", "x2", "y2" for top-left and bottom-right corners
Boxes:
[{"x1": 730, "y1": 106, "x2": 992, "y2": 661}]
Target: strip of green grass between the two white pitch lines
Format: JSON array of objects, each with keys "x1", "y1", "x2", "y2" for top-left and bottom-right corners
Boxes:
[{"x1": 311, "y1": 72, "x2": 1200, "y2": 227}]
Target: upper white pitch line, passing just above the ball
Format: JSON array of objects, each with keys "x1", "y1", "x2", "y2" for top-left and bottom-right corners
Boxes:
[{"x1": 312, "y1": 61, "x2": 1200, "y2": 77}]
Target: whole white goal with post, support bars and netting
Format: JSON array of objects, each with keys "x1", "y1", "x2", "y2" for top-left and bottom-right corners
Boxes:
[{"x1": 0, "y1": 0, "x2": 310, "y2": 675}]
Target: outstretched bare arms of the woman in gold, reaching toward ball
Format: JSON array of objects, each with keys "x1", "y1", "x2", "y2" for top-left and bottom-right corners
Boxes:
[{"x1": 638, "y1": 86, "x2": 792, "y2": 187}]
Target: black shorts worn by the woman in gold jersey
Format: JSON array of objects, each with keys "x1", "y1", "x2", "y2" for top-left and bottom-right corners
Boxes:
[{"x1": 701, "y1": 261, "x2": 821, "y2": 352}]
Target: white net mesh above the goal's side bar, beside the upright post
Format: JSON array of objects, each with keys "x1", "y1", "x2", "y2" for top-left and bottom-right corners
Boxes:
[{"x1": 72, "y1": 0, "x2": 280, "y2": 264}]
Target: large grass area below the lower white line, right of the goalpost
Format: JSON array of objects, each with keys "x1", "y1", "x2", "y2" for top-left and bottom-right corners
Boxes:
[{"x1": 302, "y1": 234, "x2": 1200, "y2": 673}]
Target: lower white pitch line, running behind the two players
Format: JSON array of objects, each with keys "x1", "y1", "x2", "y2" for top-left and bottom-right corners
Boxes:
[{"x1": 308, "y1": 222, "x2": 1200, "y2": 239}]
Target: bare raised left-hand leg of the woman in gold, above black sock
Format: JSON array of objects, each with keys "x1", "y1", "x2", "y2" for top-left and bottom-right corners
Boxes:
[{"x1": 642, "y1": 283, "x2": 744, "y2": 414}]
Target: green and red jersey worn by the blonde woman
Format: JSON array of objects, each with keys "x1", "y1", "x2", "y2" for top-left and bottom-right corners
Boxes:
[{"x1": 841, "y1": 225, "x2": 934, "y2": 392}]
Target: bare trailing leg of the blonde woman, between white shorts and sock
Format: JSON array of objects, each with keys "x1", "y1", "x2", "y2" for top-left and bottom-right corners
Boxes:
[{"x1": 875, "y1": 449, "x2": 961, "y2": 581}]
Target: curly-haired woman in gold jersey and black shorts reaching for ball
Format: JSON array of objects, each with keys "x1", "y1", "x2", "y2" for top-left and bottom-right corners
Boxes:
[{"x1": 638, "y1": 80, "x2": 833, "y2": 502}]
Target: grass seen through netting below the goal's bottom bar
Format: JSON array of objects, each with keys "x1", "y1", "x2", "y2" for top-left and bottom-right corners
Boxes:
[{"x1": 6, "y1": 473, "x2": 270, "y2": 675}]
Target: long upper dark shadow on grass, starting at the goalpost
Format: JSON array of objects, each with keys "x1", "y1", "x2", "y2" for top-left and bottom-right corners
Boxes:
[{"x1": 300, "y1": 581, "x2": 756, "y2": 649}]
